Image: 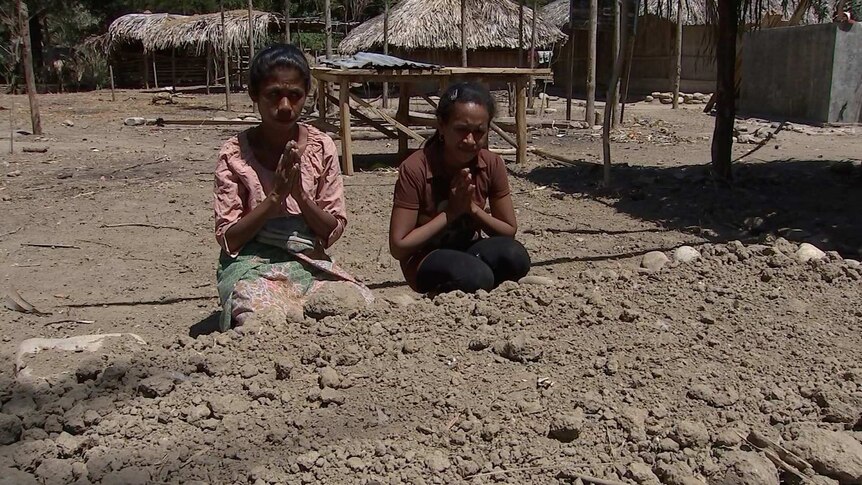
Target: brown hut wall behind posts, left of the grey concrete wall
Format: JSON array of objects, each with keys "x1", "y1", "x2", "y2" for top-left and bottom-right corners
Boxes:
[{"x1": 553, "y1": 15, "x2": 716, "y2": 94}]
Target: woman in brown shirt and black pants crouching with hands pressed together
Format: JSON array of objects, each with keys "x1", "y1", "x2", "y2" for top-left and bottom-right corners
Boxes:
[{"x1": 389, "y1": 83, "x2": 530, "y2": 293}]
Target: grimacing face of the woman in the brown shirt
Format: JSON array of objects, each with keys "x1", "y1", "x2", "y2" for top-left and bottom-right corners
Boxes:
[{"x1": 439, "y1": 103, "x2": 491, "y2": 166}]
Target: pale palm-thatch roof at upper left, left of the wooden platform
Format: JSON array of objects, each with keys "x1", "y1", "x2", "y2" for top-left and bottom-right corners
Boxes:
[{"x1": 107, "y1": 10, "x2": 279, "y2": 55}]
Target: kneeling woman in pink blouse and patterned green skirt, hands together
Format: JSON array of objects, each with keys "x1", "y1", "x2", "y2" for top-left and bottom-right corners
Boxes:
[{"x1": 213, "y1": 44, "x2": 372, "y2": 331}]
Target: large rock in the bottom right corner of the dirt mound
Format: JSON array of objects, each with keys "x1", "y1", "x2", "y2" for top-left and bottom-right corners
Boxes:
[{"x1": 787, "y1": 426, "x2": 862, "y2": 483}]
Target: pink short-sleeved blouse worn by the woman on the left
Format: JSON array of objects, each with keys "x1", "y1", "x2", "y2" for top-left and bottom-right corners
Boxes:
[{"x1": 213, "y1": 125, "x2": 347, "y2": 257}]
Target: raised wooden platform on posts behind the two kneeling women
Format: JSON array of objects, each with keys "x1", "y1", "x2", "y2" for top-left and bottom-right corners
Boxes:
[{"x1": 311, "y1": 67, "x2": 553, "y2": 175}]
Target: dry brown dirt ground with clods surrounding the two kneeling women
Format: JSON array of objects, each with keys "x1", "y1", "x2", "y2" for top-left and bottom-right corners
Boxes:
[{"x1": 0, "y1": 91, "x2": 862, "y2": 485}]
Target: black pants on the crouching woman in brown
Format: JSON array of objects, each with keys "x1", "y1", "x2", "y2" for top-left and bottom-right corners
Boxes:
[{"x1": 416, "y1": 236, "x2": 530, "y2": 293}]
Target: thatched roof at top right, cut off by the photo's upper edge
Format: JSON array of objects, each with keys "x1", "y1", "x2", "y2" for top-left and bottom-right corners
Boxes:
[{"x1": 539, "y1": 0, "x2": 830, "y2": 26}]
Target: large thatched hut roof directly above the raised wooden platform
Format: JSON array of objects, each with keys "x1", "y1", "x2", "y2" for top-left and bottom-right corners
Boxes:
[{"x1": 338, "y1": 0, "x2": 566, "y2": 54}]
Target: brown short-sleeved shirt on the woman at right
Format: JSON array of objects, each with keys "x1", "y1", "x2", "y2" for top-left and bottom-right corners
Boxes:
[{"x1": 393, "y1": 143, "x2": 511, "y2": 288}]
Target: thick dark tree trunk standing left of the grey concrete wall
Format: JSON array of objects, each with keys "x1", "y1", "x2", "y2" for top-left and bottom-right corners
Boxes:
[{"x1": 712, "y1": 0, "x2": 737, "y2": 182}]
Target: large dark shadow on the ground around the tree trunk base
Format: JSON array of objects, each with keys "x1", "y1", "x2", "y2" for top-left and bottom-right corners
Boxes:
[{"x1": 515, "y1": 160, "x2": 862, "y2": 258}]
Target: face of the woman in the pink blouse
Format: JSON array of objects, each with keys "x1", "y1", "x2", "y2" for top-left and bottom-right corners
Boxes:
[{"x1": 252, "y1": 67, "x2": 307, "y2": 129}]
